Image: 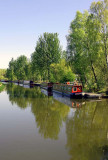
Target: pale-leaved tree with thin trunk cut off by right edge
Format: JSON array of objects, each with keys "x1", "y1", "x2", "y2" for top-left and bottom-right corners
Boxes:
[{"x1": 90, "y1": 0, "x2": 108, "y2": 87}]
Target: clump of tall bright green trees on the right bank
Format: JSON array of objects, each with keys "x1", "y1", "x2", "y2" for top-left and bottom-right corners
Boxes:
[{"x1": 67, "y1": 0, "x2": 108, "y2": 90}]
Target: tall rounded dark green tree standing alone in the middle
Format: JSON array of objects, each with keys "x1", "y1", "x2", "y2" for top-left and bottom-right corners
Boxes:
[{"x1": 32, "y1": 33, "x2": 61, "y2": 80}]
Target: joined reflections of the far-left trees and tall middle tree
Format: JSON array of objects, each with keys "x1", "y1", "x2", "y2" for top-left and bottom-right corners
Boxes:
[{"x1": 7, "y1": 84, "x2": 70, "y2": 139}]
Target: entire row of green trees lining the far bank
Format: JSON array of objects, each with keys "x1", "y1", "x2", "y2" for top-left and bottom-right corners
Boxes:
[{"x1": 6, "y1": 0, "x2": 108, "y2": 90}]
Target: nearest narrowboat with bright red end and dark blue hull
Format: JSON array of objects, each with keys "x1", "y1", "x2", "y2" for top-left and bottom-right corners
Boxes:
[{"x1": 53, "y1": 82, "x2": 82, "y2": 98}]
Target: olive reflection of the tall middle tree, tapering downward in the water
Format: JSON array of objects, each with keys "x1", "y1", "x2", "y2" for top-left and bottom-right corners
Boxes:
[{"x1": 31, "y1": 97, "x2": 69, "y2": 139}]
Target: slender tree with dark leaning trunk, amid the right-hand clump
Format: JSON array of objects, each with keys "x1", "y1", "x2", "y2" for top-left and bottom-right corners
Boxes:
[{"x1": 84, "y1": 14, "x2": 101, "y2": 88}]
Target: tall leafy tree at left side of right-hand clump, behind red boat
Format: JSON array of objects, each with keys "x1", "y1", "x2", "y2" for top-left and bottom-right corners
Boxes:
[{"x1": 67, "y1": 11, "x2": 89, "y2": 86}]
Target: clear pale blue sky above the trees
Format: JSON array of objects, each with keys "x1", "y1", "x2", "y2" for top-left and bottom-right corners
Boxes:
[{"x1": 0, "y1": 0, "x2": 96, "y2": 68}]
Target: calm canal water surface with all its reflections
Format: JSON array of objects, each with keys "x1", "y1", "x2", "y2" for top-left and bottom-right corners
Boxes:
[{"x1": 0, "y1": 84, "x2": 108, "y2": 160}]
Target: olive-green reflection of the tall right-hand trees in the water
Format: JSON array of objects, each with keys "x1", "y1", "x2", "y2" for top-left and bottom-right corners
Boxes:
[{"x1": 66, "y1": 100, "x2": 108, "y2": 160}]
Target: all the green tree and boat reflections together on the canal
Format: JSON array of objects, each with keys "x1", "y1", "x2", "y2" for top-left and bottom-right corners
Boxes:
[{"x1": 2, "y1": 84, "x2": 108, "y2": 160}]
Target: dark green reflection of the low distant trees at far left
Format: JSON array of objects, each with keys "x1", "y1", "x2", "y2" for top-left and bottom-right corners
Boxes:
[{"x1": 6, "y1": 83, "x2": 45, "y2": 109}]
